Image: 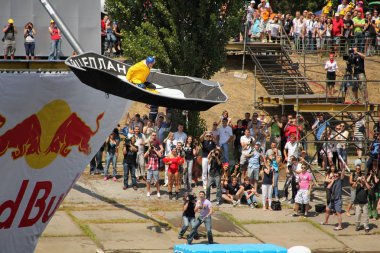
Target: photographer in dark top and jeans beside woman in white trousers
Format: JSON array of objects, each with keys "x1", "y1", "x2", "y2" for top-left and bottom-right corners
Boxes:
[{"x1": 206, "y1": 148, "x2": 222, "y2": 205}]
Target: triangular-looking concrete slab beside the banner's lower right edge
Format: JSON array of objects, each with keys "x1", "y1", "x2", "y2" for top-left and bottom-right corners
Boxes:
[{"x1": 42, "y1": 211, "x2": 83, "y2": 236}]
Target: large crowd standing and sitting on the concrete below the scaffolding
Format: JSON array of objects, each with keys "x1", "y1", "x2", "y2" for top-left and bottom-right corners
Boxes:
[{"x1": 90, "y1": 105, "x2": 380, "y2": 230}]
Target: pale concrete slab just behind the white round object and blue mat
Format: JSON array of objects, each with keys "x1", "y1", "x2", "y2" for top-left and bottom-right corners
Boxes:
[{"x1": 244, "y1": 222, "x2": 346, "y2": 252}]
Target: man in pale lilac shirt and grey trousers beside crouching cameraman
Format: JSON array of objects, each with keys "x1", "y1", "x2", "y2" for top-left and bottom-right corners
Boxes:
[{"x1": 187, "y1": 191, "x2": 214, "y2": 244}]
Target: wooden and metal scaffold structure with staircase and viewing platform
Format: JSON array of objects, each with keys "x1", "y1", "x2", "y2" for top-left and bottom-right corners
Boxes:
[{"x1": 226, "y1": 42, "x2": 380, "y2": 174}]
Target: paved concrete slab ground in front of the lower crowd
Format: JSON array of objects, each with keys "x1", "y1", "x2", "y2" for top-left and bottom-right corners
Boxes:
[{"x1": 36, "y1": 173, "x2": 380, "y2": 253}]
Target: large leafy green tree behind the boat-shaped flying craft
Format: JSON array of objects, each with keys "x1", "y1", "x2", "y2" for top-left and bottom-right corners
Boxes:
[{"x1": 106, "y1": 0, "x2": 244, "y2": 134}]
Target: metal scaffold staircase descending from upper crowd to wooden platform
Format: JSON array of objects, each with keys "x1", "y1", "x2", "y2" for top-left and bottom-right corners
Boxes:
[{"x1": 246, "y1": 43, "x2": 313, "y2": 95}]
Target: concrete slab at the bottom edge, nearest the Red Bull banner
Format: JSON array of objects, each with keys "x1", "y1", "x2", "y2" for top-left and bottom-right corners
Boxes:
[{"x1": 35, "y1": 236, "x2": 97, "y2": 253}]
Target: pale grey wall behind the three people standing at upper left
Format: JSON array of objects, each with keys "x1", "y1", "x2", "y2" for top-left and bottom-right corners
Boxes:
[{"x1": 0, "y1": 0, "x2": 100, "y2": 56}]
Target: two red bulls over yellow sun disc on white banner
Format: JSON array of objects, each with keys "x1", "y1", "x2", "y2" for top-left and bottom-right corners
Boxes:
[{"x1": 0, "y1": 100, "x2": 104, "y2": 169}]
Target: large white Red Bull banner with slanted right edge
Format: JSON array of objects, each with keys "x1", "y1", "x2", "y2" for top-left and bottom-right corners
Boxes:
[{"x1": 0, "y1": 73, "x2": 132, "y2": 253}]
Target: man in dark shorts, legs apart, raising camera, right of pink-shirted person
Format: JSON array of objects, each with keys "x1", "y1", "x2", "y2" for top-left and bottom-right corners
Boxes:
[{"x1": 321, "y1": 170, "x2": 344, "y2": 230}]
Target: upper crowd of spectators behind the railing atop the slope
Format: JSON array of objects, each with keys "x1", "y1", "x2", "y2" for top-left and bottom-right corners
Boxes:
[{"x1": 239, "y1": 0, "x2": 380, "y2": 56}]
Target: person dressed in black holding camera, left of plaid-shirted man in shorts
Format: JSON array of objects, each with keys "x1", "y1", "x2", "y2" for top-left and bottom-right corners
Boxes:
[{"x1": 123, "y1": 136, "x2": 138, "y2": 191}]
